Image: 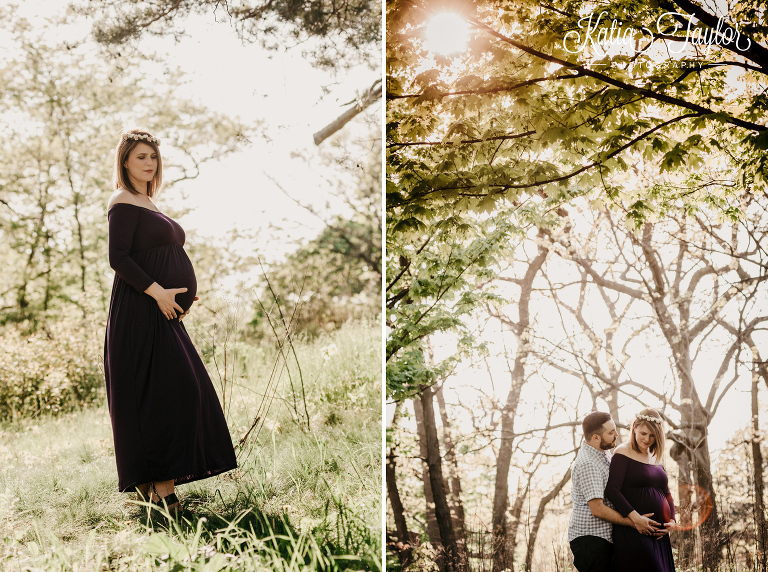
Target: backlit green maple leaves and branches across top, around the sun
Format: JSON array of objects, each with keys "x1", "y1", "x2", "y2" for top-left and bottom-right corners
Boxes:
[{"x1": 386, "y1": 0, "x2": 768, "y2": 218}]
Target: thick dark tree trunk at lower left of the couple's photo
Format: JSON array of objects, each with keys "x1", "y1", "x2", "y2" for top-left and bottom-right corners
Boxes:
[{"x1": 421, "y1": 387, "x2": 468, "y2": 572}]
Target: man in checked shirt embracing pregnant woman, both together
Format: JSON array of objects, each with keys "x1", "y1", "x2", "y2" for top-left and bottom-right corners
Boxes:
[{"x1": 568, "y1": 409, "x2": 677, "y2": 572}]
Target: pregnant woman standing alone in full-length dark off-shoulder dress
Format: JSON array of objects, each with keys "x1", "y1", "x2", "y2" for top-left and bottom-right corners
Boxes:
[{"x1": 104, "y1": 130, "x2": 237, "y2": 514}]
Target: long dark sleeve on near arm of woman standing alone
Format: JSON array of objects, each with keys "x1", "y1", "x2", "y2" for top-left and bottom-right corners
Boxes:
[{"x1": 107, "y1": 203, "x2": 155, "y2": 294}]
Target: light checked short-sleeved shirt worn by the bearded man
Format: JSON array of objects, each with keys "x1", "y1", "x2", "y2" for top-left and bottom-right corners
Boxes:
[{"x1": 568, "y1": 441, "x2": 613, "y2": 542}]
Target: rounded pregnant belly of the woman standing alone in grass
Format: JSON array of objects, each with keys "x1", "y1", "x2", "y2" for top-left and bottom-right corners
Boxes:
[{"x1": 137, "y1": 244, "x2": 197, "y2": 312}]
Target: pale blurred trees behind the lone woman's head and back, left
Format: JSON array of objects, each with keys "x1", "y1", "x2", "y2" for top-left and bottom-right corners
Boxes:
[{"x1": 0, "y1": 8, "x2": 255, "y2": 331}]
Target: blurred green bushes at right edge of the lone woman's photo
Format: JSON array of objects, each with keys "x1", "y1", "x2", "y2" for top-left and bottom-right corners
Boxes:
[{"x1": 251, "y1": 137, "x2": 382, "y2": 337}]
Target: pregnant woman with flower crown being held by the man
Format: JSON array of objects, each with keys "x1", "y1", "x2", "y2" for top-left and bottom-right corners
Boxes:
[{"x1": 605, "y1": 409, "x2": 675, "y2": 572}]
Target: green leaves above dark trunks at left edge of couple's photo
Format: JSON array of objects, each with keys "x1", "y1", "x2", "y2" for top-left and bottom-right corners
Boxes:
[{"x1": 386, "y1": 206, "x2": 520, "y2": 400}]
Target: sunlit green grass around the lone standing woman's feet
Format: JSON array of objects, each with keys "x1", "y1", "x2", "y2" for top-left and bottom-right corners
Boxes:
[{"x1": 0, "y1": 323, "x2": 382, "y2": 572}]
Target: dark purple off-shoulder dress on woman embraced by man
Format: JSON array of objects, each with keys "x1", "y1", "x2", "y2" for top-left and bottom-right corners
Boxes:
[{"x1": 605, "y1": 454, "x2": 675, "y2": 572}]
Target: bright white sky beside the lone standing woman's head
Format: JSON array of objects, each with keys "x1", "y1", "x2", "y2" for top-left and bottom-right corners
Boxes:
[{"x1": 6, "y1": 0, "x2": 381, "y2": 259}]
